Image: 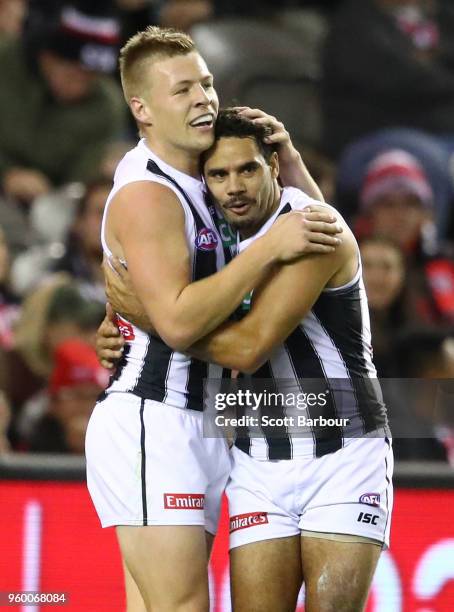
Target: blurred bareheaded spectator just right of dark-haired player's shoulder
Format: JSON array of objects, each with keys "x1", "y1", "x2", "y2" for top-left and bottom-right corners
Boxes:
[{"x1": 359, "y1": 236, "x2": 409, "y2": 377}]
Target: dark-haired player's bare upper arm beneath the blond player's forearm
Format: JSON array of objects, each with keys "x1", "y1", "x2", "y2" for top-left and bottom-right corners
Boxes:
[{"x1": 188, "y1": 232, "x2": 357, "y2": 373}]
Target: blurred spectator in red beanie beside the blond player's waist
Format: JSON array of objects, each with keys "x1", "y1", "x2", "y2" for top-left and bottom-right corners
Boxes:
[{"x1": 28, "y1": 339, "x2": 109, "y2": 455}]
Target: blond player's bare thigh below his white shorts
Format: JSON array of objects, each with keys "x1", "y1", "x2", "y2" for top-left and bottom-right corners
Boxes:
[{"x1": 117, "y1": 525, "x2": 209, "y2": 612}]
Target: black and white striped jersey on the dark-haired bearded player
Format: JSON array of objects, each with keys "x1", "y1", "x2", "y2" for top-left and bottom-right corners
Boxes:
[{"x1": 235, "y1": 187, "x2": 387, "y2": 459}]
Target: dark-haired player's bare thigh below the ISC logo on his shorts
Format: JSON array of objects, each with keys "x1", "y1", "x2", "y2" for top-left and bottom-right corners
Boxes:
[{"x1": 301, "y1": 536, "x2": 381, "y2": 612}]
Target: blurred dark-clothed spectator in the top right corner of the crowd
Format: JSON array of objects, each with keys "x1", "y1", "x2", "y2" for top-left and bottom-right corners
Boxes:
[{"x1": 322, "y1": 0, "x2": 454, "y2": 157}]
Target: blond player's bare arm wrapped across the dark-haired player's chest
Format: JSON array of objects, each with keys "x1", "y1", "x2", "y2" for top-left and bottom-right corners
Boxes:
[{"x1": 109, "y1": 182, "x2": 334, "y2": 350}]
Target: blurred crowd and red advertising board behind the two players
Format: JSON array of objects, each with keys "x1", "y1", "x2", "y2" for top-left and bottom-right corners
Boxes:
[{"x1": 0, "y1": 0, "x2": 454, "y2": 612}]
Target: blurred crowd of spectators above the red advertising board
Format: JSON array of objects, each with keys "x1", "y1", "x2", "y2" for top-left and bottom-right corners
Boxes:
[{"x1": 0, "y1": 0, "x2": 454, "y2": 464}]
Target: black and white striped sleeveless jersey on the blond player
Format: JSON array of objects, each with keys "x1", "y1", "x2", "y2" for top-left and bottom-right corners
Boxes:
[{"x1": 101, "y1": 139, "x2": 236, "y2": 410}]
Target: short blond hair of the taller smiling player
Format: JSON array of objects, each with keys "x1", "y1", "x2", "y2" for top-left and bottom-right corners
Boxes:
[{"x1": 120, "y1": 26, "x2": 197, "y2": 103}]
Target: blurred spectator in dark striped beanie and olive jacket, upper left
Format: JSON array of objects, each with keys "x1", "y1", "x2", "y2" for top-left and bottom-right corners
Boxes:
[{"x1": 0, "y1": 6, "x2": 124, "y2": 252}]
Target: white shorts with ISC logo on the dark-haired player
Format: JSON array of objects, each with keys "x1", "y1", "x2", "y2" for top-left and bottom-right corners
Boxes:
[{"x1": 226, "y1": 438, "x2": 393, "y2": 548}]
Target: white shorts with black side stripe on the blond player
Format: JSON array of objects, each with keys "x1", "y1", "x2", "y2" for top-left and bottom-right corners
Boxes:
[{"x1": 85, "y1": 393, "x2": 231, "y2": 534}]
